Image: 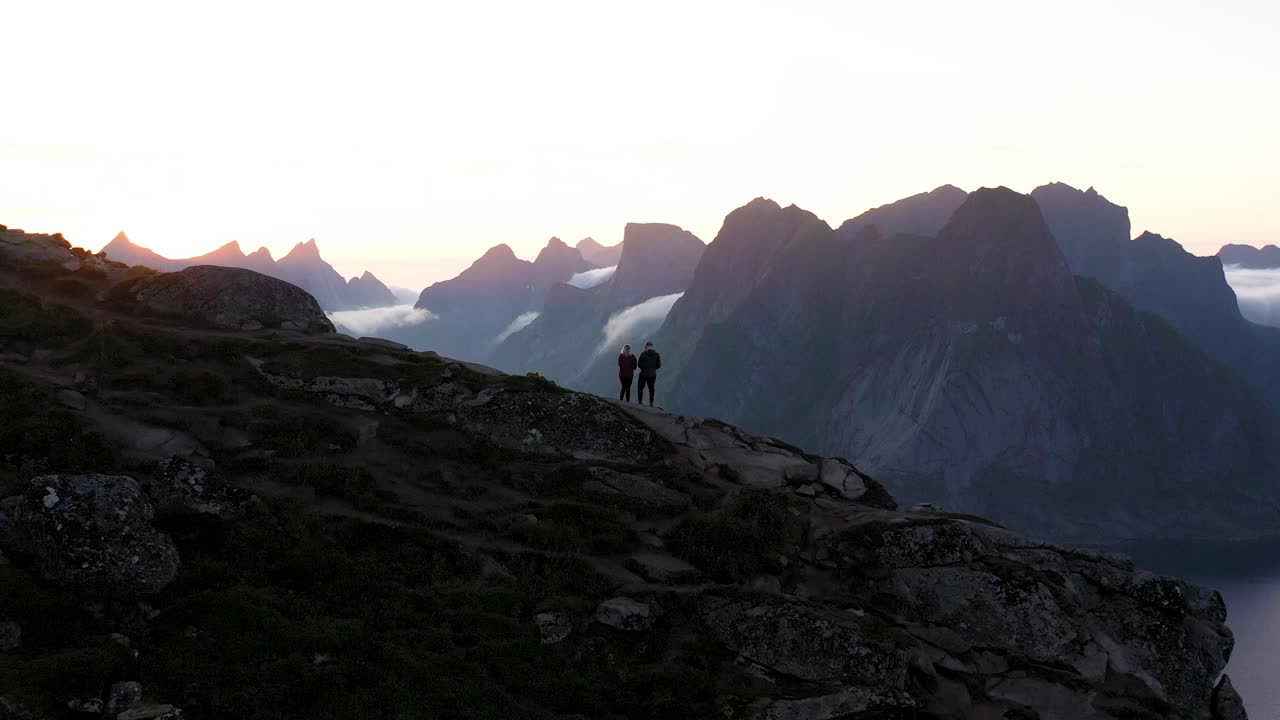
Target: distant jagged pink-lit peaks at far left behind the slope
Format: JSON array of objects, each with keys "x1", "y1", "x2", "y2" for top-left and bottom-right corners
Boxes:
[{"x1": 102, "y1": 232, "x2": 398, "y2": 313}]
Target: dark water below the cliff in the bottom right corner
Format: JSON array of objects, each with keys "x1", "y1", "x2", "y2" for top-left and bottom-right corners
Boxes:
[{"x1": 1115, "y1": 538, "x2": 1280, "y2": 720}]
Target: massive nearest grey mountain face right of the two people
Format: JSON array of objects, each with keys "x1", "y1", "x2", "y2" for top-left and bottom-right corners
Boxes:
[{"x1": 662, "y1": 190, "x2": 1280, "y2": 542}]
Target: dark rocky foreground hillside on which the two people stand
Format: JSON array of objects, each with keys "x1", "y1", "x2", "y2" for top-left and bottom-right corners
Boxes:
[{"x1": 0, "y1": 226, "x2": 1243, "y2": 720}]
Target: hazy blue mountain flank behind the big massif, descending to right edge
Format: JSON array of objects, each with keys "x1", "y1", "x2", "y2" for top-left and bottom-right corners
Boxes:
[{"x1": 1032, "y1": 183, "x2": 1280, "y2": 407}]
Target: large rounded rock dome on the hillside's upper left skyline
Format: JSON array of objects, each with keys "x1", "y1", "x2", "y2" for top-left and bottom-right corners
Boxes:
[{"x1": 111, "y1": 265, "x2": 334, "y2": 333}]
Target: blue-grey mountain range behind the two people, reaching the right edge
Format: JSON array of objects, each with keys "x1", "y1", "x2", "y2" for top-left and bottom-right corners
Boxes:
[{"x1": 401, "y1": 183, "x2": 1280, "y2": 543}]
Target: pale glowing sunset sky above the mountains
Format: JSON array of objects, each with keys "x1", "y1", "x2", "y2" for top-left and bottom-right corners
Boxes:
[{"x1": 0, "y1": 0, "x2": 1280, "y2": 288}]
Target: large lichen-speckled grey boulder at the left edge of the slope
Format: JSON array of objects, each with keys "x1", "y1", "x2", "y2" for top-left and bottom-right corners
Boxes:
[{"x1": 0, "y1": 475, "x2": 179, "y2": 598}]
